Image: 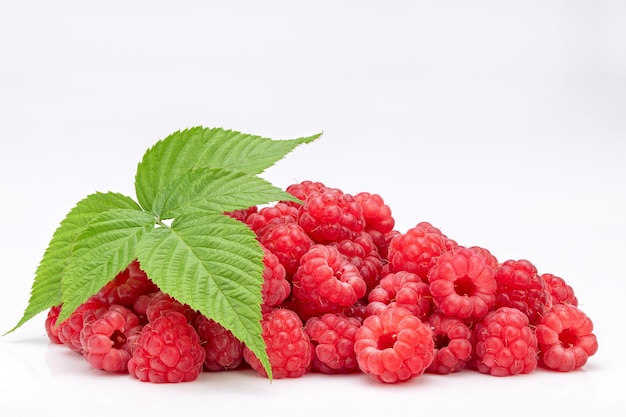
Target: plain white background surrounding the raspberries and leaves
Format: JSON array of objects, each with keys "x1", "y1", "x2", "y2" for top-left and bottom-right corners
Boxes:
[{"x1": 0, "y1": 0, "x2": 626, "y2": 416}]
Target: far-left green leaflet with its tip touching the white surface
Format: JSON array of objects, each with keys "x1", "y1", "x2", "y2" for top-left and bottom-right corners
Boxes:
[{"x1": 5, "y1": 192, "x2": 141, "y2": 334}]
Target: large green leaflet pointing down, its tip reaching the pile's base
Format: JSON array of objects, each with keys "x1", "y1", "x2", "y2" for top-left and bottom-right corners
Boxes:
[{"x1": 136, "y1": 212, "x2": 271, "y2": 375}]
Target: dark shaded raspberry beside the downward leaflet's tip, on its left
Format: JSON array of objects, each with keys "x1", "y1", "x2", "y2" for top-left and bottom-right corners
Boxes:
[{"x1": 194, "y1": 315, "x2": 243, "y2": 371}]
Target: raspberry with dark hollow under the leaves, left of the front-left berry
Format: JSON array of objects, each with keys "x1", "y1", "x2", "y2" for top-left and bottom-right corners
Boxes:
[{"x1": 80, "y1": 304, "x2": 143, "y2": 372}]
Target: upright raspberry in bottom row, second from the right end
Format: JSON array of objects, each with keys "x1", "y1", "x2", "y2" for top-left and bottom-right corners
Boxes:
[{"x1": 474, "y1": 307, "x2": 537, "y2": 376}]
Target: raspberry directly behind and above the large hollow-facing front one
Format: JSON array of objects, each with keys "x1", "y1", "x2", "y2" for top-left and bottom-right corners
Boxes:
[{"x1": 367, "y1": 271, "x2": 431, "y2": 320}]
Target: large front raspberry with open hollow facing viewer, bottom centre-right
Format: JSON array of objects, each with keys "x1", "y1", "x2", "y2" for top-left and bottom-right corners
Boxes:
[{"x1": 354, "y1": 307, "x2": 434, "y2": 384}]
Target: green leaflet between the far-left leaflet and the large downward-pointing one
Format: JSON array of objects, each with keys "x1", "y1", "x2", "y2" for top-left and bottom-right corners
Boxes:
[{"x1": 57, "y1": 208, "x2": 156, "y2": 323}]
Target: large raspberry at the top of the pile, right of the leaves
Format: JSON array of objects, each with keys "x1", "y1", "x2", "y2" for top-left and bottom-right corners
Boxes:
[{"x1": 298, "y1": 187, "x2": 365, "y2": 243}]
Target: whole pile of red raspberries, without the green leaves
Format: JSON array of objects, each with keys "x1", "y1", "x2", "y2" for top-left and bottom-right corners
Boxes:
[{"x1": 45, "y1": 181, "x2": 598, "y2": 384}]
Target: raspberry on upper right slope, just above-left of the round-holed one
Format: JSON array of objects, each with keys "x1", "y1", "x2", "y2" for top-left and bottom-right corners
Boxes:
[{"x1": 388, "y1": 222, "x2": 447, "y2": 281}]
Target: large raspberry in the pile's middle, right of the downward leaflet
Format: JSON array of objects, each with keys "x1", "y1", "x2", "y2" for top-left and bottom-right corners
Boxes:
[{"x1": 292, "y1": 244, "x2": 367, "y2": 312}]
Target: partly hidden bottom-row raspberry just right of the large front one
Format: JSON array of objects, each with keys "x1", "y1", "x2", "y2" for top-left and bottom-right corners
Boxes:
[{"x1": 426, "y1": 312, "x2": 472, "y2": 375}]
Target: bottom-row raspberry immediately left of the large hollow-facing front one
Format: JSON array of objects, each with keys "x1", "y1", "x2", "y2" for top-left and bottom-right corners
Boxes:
[{"x1": 304, "y1": 313, "x2": 361, "y2": 374}]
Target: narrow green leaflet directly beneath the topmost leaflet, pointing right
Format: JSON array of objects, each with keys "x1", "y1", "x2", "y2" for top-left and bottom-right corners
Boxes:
[{"x1": 154, "y1": 168, "x2": 300, "y2": 219}]
